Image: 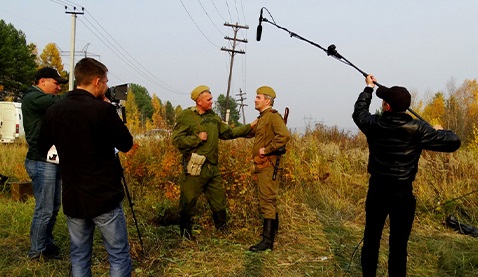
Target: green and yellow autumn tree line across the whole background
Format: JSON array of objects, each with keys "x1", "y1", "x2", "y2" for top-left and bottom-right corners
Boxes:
[{"x1": 0, "y1": 20, "x2": 478, "y2": 143}]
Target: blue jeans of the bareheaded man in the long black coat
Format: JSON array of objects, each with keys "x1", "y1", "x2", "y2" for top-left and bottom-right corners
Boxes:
[{"x1": 67, "y1": 203, "x2": 132, "y2": 276}]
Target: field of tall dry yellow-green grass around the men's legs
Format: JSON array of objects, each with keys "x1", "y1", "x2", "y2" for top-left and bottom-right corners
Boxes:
[{"x1": 0, "y1": 125, "x2": 478, "y2": 277}]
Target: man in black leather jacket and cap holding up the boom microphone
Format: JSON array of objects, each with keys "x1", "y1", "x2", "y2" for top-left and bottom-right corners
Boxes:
[{"x1": 352, "y1": 75, "x2": 461, "y2": 277}]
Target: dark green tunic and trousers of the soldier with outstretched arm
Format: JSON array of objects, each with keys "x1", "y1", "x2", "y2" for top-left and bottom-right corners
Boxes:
[{"x1": 172, "y1": 107, "x2": 252, "y2": 216}]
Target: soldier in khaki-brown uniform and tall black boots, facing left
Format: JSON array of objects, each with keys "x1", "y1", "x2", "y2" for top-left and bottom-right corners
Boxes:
[{"x1": 249, "y1": 86, "x2": 290, "y2": 252}]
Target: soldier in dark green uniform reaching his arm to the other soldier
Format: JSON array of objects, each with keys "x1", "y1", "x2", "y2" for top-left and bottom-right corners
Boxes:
[{"x1": 173, "y1": 85, "x2": 255, "y2": 238}]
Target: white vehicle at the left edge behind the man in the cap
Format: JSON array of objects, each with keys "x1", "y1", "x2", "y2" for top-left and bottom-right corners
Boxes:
[{"x1": 0, "y1": 101, "x2": 25, "y2": 143}]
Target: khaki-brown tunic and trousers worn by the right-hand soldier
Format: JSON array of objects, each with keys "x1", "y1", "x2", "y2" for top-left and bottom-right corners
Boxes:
[{"x1": 252, "y1": 107, "x2": 290, "y2": 219}]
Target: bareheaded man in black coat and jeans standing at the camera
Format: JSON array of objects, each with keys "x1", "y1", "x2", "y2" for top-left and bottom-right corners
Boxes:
[{"x1": 39, "y1": 58, "x2": 133, "y2": 276}]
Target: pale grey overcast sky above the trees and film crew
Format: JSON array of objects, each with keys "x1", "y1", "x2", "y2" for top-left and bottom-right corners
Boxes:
[{"x1": 0, "y1": 0, "x2": 478, "y2": 133}]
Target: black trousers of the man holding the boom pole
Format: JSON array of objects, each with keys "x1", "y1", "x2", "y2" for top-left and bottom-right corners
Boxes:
[{"x1": 361, "y1": 178, "x2": 416, "y2": 277}]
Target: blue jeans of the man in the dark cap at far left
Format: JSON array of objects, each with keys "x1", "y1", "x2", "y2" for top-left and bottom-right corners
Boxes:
[{"x1": 25, "y1": 159, "x2": 61, "y2": 256}]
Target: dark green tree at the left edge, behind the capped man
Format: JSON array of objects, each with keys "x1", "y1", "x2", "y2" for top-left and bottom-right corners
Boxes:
[{"x1": 0, "y1": 20, "x2": 37, "y2": 94}]
